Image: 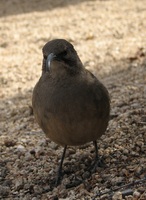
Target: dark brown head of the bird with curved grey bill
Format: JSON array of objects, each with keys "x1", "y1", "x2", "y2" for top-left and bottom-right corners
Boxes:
[{"x1": 42, "y1": 39, "x2": 83, "y2": 76}]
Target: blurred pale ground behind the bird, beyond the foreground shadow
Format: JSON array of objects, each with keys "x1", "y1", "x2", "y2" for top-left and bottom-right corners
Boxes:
[{"x1": 0, "y1": 0, "x2": 146, "y2": 97}]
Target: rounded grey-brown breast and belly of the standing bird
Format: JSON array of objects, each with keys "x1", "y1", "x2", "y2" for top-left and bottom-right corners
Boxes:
[{"x1": 33, "y1": 75, "x2": 108, "y2": 145}]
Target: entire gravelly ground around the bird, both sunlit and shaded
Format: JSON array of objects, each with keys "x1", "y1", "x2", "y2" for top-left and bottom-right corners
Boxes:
[{"x1": 0, "y1": 0, "x2": 146, "y2": 200}]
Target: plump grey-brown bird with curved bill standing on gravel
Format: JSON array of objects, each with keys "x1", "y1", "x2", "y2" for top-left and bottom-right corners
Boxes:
[{"x1": 32, "y1": 39, "x2": 110, "y2": 186}]
